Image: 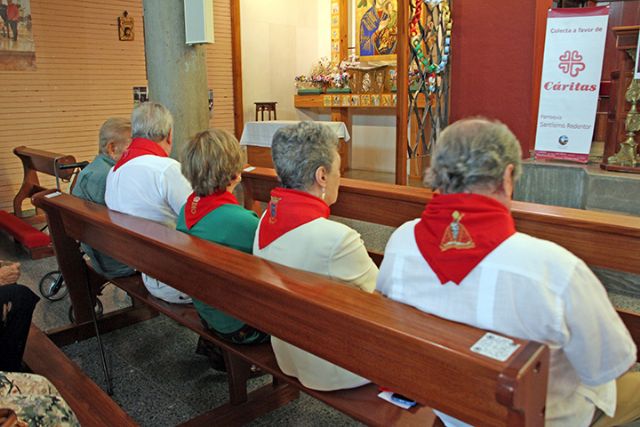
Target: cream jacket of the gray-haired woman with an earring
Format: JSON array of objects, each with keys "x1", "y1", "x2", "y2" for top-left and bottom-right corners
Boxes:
[{"x1": 253, "y1": 218, "x2": 378, "y2": 391}]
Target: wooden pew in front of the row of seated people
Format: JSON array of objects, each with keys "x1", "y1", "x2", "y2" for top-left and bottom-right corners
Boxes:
[{"x1": 242, "y1": 168, "x2": 640, "y2": 358}]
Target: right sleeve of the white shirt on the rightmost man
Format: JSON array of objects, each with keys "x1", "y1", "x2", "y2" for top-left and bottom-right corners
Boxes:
[{"x1": 563, "y1": 261, "x2": 637, "y2": 386}]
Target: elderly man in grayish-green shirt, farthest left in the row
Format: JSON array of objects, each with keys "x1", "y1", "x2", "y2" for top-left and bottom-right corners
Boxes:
[{"x1": 71, "y1": 117, "x2": 134, "y2": 278}]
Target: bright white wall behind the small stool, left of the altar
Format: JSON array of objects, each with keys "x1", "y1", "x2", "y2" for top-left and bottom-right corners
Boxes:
[{"x1": 240, "y1": 0, "x2": 331, "y2": 121}]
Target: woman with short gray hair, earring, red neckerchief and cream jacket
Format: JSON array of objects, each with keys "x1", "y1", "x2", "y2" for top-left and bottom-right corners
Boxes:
[{"x1": 253, "y1": 122, "x2": 378, "y2": 390}]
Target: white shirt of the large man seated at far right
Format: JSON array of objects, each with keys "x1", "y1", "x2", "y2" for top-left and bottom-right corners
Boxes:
[{"x1": 377, "y1": 219, "x2": 637, "y2": 427}]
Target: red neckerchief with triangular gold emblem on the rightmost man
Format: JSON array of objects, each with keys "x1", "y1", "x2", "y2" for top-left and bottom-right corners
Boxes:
[{"x1": 414, "y1": 193, "x2": 516, "y2": 285}]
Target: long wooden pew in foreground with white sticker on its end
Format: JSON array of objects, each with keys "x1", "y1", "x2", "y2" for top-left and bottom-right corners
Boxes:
[{"x1": 34, "y1": 194, "x2": 549, "y2": 426}]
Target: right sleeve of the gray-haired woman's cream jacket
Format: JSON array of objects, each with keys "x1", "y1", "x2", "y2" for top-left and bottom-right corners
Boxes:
[{"x1": 329, "y1": 229, "x2": 378, "y2": 292}]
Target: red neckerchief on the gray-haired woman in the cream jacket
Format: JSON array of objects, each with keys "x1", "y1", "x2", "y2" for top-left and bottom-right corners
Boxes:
[{"x1": 258, "y1": 188, "x2": 330, "y2": 249}]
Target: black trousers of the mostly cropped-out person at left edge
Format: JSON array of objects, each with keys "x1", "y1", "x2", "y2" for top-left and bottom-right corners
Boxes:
[{"x1": 0, "y1": 284, "x2": 40, "y2": 372}]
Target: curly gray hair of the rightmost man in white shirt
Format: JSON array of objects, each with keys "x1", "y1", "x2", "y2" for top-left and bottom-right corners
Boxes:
[{"x1": 425, "y1": 117, "x2": 522, "y2": 194}]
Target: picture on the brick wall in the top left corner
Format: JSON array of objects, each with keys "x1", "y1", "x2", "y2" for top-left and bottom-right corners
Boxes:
[{"x1": 0, "y1": 0, "x2": 36, "y2": 71}]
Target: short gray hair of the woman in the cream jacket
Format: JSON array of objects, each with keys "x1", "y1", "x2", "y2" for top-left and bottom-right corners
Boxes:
[{"x1": 271, "y1": 122, "x2": 338, "y2": 191}]
